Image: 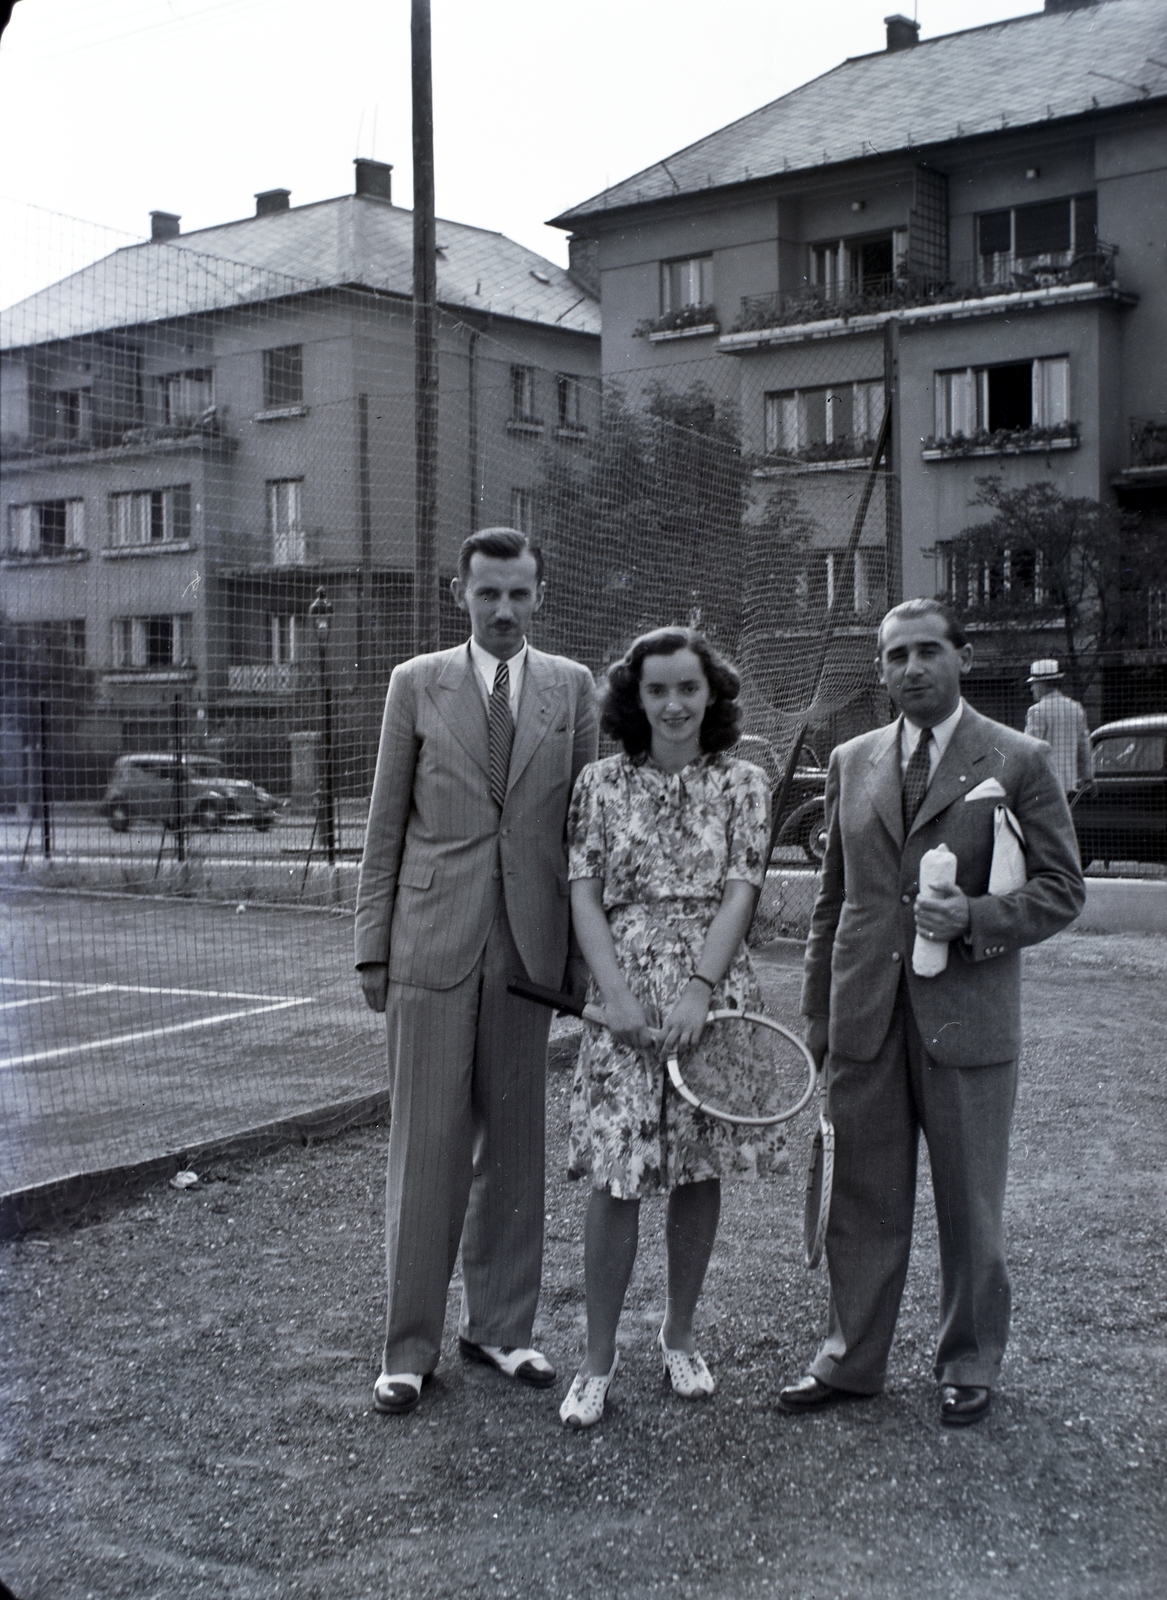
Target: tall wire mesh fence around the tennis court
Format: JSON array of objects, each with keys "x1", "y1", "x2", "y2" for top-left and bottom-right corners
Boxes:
[{"x1": 0, "y1": 196, "x2": 1165, "y2": 1190}]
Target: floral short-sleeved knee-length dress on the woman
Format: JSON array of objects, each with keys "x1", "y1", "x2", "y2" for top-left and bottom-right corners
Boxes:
[{"x1": 567, "y1": 754, "x2": 786, "y2": 1200}]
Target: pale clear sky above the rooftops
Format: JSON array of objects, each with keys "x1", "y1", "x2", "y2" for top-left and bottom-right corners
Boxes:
[{"x1": 0, "y1": 0, "x2": 1041, "y2": 306}]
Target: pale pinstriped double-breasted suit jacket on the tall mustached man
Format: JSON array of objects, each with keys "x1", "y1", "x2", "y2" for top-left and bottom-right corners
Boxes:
[{"x1": 355, "y1": 645, "x2": 597, "y2": 989}]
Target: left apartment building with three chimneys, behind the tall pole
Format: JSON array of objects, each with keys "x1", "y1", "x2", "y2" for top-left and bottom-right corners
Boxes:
[{"x1": 0, "y1": 160, "x2": 600, "y2": 787}]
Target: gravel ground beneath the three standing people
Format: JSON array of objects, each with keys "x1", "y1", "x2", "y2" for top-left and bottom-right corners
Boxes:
[{"x1": 0, "y1": 934, "x2": 1167, "y2": 1600}]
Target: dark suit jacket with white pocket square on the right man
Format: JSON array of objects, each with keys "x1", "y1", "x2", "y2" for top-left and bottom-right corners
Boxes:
[{"x1": 802, "y1": 704, "x2": 1085, "y2": 1067}]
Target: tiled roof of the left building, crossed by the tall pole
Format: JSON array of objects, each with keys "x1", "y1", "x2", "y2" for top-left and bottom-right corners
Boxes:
[{"x1": 0, "y1": 195, "x2": 600, "y2": 349}]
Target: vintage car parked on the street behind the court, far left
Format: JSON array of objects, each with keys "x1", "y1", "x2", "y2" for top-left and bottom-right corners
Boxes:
[{"x1": 101, "y1": 754, "x2": 280, "y2": 834}]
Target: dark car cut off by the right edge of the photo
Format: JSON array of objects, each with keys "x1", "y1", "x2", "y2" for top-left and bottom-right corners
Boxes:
[{"x1": 1071, "y1": 712, "x2": 1167, "y2": 866}]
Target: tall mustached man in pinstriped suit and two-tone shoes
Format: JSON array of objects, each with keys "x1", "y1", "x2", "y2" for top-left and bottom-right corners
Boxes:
[{"x1": 355, "y1": 528, "x2": 597, "y2": 1413}]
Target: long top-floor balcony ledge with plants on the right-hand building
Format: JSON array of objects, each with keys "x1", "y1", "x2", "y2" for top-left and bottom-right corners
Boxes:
[{"x1": 732, "y1": 243, "x2": 1117, "y2": 333}]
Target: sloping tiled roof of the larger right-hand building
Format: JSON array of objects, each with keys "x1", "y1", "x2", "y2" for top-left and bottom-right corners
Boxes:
[{"x1": 554, "y1": 0, "x2": 1167, "y2": 227}]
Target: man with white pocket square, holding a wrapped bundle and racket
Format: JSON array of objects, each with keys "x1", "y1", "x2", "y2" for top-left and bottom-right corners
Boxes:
[{"x1": 780, "y1": 600, "x2": 1085, "y2": 1427}]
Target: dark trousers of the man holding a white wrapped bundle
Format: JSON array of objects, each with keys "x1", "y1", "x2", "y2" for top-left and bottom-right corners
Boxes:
[{"x1": 810, "y1": 984, "x2": 1017, "y2": 1394}]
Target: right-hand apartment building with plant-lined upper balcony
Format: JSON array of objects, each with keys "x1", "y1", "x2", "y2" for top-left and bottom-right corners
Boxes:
[{"x1": 554, "y1": 0, "x2": 1167, "y2": 715}]
